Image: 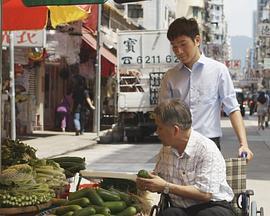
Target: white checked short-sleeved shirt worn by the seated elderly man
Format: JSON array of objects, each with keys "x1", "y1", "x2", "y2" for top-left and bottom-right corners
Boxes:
[{"x1": 154, "y1": 130, "x2": 234, "y2": 208}]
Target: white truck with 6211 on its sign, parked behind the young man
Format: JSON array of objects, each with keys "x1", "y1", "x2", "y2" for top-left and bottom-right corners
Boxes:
[{"x1": 117, "y1": 30, "x2": 178, "y2": 142}]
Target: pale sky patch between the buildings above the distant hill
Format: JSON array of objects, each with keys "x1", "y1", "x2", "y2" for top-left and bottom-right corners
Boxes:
[{"x1": 224, "y1": 0, "x2": 257, "y2": 37}]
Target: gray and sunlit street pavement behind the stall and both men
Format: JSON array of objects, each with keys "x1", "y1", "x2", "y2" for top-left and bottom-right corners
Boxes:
[{"x1": 21, "y1": 115, "x2": 270, "y2": 215}]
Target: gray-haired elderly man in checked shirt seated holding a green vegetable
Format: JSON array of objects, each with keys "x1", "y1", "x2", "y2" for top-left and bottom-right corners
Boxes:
[{"x1": 136, "y1": 100, "x2": 262, "y2": 216}]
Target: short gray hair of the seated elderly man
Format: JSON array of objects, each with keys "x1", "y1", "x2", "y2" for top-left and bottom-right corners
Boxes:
[{"x1": 154, "y1": 99, "x2": 192, "y2": 130}]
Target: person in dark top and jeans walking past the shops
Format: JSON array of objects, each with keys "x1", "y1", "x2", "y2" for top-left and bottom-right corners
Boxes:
[{"x1": 72, "y1": 74, "x2": 95, "y2": 136}]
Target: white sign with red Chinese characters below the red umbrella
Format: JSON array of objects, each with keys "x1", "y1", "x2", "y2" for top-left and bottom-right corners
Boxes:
[{"x1": 2, "y1": 30, "x2": 46, "y2": 47}]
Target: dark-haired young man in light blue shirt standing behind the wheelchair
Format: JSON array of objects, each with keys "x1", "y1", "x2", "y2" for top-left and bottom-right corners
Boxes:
[{"x1": 159, "y1": 17, "x2": 253, "y2": 160}]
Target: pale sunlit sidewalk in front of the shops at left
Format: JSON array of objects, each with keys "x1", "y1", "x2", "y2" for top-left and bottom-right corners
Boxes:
[{"x1": 21, "y1": 131, "x2": 105, "y2": 158}]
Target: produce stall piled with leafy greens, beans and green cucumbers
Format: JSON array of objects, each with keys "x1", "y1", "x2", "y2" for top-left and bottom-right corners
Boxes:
[{"x1": 0, "y1": 140, "x2": 152, "y2": 216}]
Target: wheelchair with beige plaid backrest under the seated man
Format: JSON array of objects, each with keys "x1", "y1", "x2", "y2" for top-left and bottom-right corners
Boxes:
[{"x1": 149, "y1": 157, "x2": 264, "y2": 216}]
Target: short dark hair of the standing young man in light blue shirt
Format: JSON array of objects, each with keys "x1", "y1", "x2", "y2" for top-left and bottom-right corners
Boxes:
[{"x1": 167, "y1": 17, "x2": 200, "y2": 41}]
